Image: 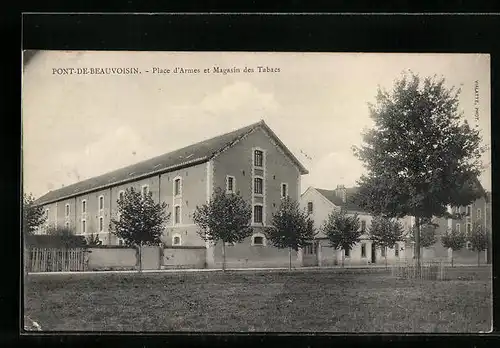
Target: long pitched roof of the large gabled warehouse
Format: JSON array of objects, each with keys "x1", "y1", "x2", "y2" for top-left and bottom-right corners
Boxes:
[{"x1": 35, "y1": 120, "x2": 308, "y2": 204}]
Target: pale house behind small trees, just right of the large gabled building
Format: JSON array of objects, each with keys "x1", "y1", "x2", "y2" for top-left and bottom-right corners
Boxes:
[{"x1": 300, "y1": 185, "x2": 411, "y2": 266}]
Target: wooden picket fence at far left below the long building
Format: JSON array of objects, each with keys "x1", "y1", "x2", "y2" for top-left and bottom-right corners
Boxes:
[{"x1": 26, "y1": 248, "x2": 87, "y2": 272}]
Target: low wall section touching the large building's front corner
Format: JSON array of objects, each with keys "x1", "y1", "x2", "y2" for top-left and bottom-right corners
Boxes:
[{"x1": 161, "y1": 246, "x2": 206, "y2": 269}]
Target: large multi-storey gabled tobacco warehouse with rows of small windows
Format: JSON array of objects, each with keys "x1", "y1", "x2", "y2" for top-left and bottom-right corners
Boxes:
[{"x1": 36, "y1": 121, "x2": 308, "y2": 267}]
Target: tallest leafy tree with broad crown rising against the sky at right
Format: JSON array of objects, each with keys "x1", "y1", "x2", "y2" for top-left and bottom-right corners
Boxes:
[{"x1": 354, "y1": 72, "x2": 485, "y2": 271}]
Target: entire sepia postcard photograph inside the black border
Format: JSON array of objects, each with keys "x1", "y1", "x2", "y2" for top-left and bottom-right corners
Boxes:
[{"x1": 20, "y1": 50, "x2": 493, "y2": 333}]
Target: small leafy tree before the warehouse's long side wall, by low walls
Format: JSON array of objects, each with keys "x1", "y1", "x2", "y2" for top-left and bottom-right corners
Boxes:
[{"x1": 109, "y1": 187, "x2": 170, "y2": 271}]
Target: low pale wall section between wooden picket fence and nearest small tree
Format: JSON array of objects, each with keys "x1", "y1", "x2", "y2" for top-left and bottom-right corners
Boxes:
[{"x1": 88, "y1": 246, "x2": 137, "y2": 271}]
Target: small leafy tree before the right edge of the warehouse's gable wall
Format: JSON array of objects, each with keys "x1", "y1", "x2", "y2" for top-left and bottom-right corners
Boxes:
[{"x1": 265, "y1": 197, "x2": 314, "y2": 270}]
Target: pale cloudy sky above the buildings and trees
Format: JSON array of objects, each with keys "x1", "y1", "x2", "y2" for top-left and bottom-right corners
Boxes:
[{"x1": 22, "y1": 51, "x2": 491, "y2": 197}]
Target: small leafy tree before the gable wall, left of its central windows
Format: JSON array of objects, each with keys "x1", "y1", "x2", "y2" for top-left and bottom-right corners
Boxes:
[{"x1": 193, "y1": 187, "x2": 253, "y2": 271}]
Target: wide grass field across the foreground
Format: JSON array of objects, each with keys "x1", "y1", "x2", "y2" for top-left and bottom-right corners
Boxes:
[{"x1": 25, "y1": 267, "x2": 492, "y2": 332}]
